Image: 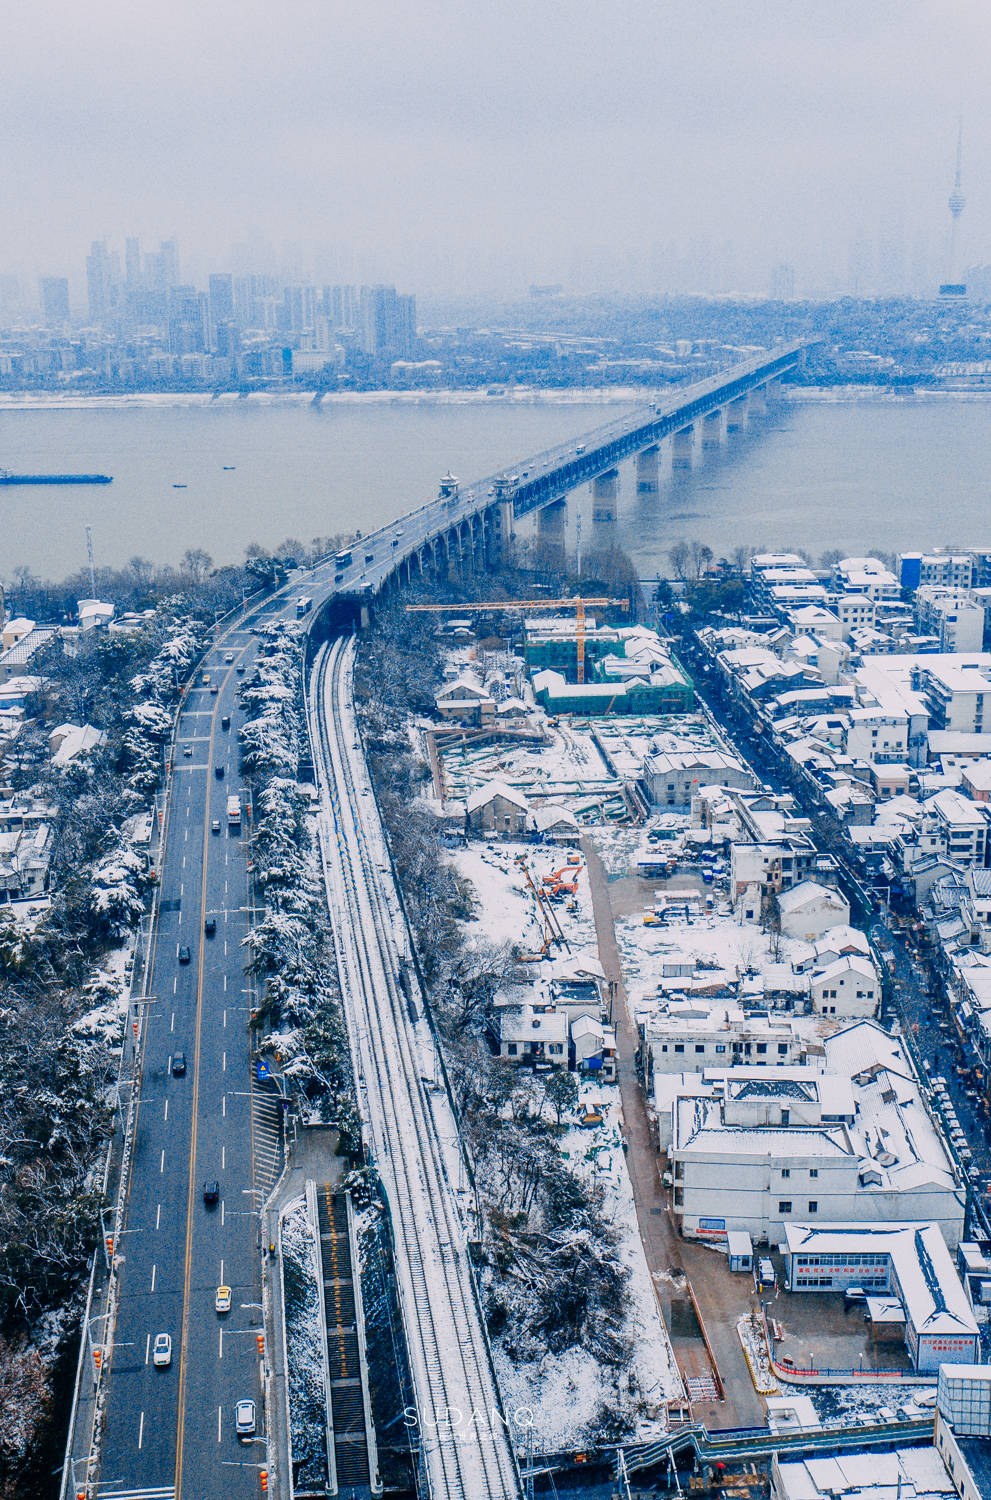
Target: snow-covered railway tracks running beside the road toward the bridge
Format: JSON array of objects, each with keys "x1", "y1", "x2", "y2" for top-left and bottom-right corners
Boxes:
[{"x1": 307, "y1": 639, "x2": 520, "y2": 1500}]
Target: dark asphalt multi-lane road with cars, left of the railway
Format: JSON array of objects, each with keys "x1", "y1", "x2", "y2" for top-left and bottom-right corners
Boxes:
[{"x1": 93, "y1": 630, "x2": 277, "y2": 1500}]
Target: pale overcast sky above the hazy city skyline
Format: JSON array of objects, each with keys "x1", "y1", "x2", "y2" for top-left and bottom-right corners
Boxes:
[{"x1": 0, "y1": 0, "x2": 991, "y2": 291}]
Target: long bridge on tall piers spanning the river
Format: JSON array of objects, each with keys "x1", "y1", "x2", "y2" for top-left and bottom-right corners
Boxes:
[{"x1": 322, "y1": 339, "x2": 816, "y2": 596}]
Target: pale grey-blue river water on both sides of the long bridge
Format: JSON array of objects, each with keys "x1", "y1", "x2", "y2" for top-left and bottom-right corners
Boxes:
[{"x1": 0, "y1": 393, "x2": 991, "y2": 578}]
